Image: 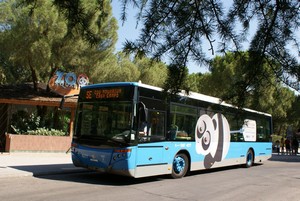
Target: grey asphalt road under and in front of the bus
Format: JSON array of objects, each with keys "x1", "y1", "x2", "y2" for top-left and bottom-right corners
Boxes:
[{"x1": 0, "y1": 156, "x2": 300, "y2": 201}]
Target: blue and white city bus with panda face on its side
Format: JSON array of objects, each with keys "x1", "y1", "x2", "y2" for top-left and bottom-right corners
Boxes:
[{"x1": 71, "y1": 82, "x2": 272, "y2": 178}]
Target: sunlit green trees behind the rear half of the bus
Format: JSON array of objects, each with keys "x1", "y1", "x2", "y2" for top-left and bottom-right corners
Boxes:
[{"x1": 185, "y1": 52, "x2": 299, "y2": 134}]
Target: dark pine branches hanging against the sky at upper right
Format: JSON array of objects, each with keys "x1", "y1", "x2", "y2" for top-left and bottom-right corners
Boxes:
[{"x1": 123, "y1": 0, "x2": 300, "y2": 98}]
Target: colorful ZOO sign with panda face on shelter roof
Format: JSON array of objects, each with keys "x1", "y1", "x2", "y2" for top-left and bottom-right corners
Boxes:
[{"x1": 48, "y1": 70, "x2": 89, "y2": 96}]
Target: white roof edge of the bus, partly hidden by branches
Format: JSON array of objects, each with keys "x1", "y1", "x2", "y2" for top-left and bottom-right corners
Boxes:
[{"x1": 82, "y1": 82, "x2": 271, "y2": 117}]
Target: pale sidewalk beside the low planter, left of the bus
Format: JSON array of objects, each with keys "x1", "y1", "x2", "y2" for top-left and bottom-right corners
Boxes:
[{"x1": 0, "y1": 152, "x2": 87, "y2": 178}]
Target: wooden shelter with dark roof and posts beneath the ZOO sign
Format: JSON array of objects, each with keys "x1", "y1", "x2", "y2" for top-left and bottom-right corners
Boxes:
[{"x1": 0, "y1": 83, "x2": 77, "y2": 152}]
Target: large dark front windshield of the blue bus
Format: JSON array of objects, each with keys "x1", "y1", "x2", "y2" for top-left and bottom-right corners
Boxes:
[{"x1": 74, "y1": 101, "x2": 132, "y2": 145}]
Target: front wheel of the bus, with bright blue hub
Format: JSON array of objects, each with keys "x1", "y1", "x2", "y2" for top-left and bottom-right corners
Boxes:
[{"x1": 171, "y1": 153, "x2": 189, "y2": 179}]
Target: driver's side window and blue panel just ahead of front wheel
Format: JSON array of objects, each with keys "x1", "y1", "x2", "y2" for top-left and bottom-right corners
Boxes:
[{"x1": 136, "y1": 110, "x2": 167, "y2": 167}]
